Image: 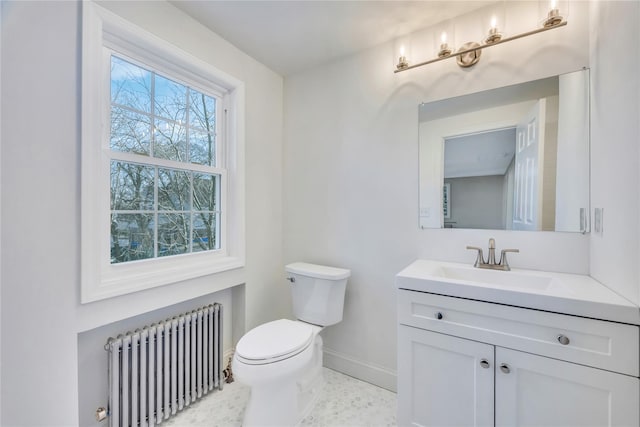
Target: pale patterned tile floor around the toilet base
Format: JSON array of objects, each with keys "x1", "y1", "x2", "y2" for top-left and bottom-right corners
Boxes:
[{"x1": 163, "y1": 368, "x2": 397, "y2": 427}]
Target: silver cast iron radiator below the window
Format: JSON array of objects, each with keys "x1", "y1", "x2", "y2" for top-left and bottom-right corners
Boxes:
[{"x1": 105, "y1": 303, "x2": 224, "y2": 427}]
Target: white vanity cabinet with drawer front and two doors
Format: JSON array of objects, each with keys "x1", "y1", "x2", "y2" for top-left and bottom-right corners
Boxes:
[{"x1": 398, "y1": 289, "x2": 640, "y2": 427}]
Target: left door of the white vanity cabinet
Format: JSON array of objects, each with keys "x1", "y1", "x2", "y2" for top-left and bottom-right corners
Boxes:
[{"x1": 398, "y1": 325, "x2": 494, "y2": 427}]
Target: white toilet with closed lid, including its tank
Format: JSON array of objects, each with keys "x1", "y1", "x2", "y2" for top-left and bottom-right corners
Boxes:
[{"x1": 232, "y1": 262, "x2": 351, "y2": 427}]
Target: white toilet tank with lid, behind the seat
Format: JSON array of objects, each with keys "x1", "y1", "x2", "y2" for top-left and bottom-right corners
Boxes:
[{"x1": 285, "y1": 262, "x2": 351, "y2": 326}]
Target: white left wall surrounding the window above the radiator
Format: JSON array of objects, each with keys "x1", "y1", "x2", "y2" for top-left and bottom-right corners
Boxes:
[{"x1": 0, "y1": 1, "x2": 290, "y2": 426}]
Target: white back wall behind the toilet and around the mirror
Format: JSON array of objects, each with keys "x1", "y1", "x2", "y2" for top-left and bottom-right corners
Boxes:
[{"x1": 284, "y1": 2, "x2": 592, "y2": 388}]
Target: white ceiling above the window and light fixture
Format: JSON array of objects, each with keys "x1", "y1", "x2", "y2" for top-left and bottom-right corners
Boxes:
[{"x1": 171, "y1": 0, "x2": 495, "y2": 76}]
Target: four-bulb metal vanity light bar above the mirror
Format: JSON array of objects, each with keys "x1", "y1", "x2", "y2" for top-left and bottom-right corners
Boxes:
[{"x1": 394, "y1": 0, "x2": 567, "y2": 73}]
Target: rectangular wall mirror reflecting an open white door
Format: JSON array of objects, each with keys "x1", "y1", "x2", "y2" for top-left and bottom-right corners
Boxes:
[{"x1": 419, "y1": 69, "x2": 589, "y2": 233}]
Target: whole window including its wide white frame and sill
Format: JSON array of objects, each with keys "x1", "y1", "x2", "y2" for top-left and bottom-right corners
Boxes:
[{"x1": 81, "y1": 3, "x2": 244, "y2": 302}]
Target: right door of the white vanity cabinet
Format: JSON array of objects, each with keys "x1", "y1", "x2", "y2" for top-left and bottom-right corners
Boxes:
[{"x1": 495, "y1": 347, "x2": 640, "y2": 427}]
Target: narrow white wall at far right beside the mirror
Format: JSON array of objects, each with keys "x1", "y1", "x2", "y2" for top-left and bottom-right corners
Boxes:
[{"x1": 590, "y1": 1, "x2": 640, "y2": 304}]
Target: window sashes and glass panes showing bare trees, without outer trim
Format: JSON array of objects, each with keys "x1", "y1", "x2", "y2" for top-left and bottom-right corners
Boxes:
[{"x1": 109, "y1": 55, "x2": 224, "y2": 263}]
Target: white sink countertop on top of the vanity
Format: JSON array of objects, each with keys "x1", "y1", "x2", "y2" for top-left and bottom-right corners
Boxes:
[{"x1": 396, "y1": 260, "x2": 640, "y2": 325}]
